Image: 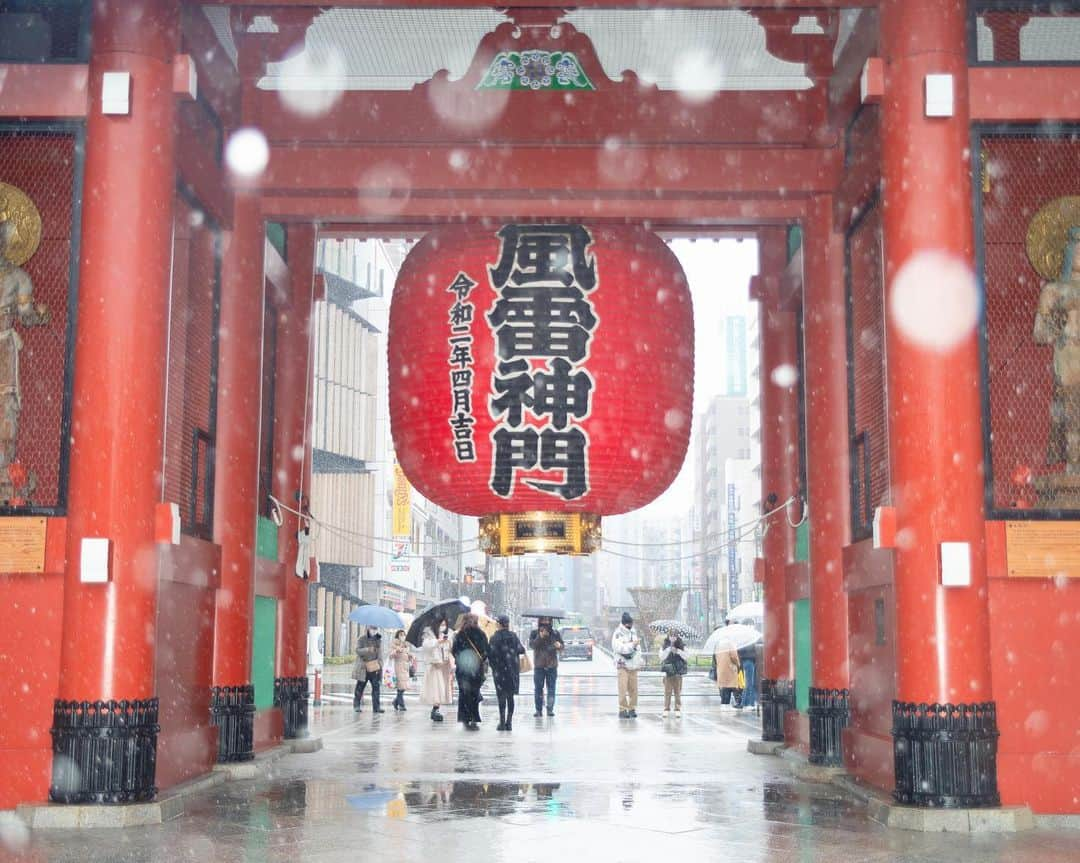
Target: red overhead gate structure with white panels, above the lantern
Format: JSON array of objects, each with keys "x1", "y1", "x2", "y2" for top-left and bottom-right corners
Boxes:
[{"x1": 185, "y1": 0, "x2": 877, "y2": 229}]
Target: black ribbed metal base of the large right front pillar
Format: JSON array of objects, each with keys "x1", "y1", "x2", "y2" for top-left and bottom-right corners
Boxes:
[{"x1": 892, "y1": 701, "x2": 1001, "y2": 809}]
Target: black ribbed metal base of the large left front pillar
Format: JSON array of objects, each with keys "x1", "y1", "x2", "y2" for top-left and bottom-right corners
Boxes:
[{"x1": 49, "y1": 698, "x2": 161, "y2": 804}]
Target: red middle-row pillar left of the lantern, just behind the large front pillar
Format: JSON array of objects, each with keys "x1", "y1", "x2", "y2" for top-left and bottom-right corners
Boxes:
[{"x1": 211, "y1": 192, "x2": 264, "y2": 761}]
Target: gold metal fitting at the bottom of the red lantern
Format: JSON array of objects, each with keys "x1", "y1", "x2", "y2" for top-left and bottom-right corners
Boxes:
[{"x1": 480, "y1": 512, "x2": 603, "y2": 557}]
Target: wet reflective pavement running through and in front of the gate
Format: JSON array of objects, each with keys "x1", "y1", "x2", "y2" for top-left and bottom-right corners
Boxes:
[{"x1": 6, "y1": 657, "x2": 1080, "y2": 863}]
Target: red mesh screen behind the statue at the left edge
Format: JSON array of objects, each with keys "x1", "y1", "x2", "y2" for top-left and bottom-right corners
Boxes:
[{"x1": 0, "y1": 125, "x2": 78, "y2": 514}]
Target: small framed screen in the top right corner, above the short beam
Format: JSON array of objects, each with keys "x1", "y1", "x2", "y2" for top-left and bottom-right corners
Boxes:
[{"x1": 970, "y1": 6, "x2": 1080, "y2": 65}]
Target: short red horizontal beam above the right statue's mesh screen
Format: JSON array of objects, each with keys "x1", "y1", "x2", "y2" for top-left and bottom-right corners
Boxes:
[{"x1": 968, "y1": 66, "x2": 1080, "y2": 123}]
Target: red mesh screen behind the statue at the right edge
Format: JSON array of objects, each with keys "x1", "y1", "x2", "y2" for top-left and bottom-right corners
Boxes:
[{"x1": 976, "y1": 131, "x2": 1080, "y2": 514}]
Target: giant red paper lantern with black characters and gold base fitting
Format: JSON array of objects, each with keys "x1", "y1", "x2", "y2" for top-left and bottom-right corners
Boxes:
[{"x1": 390, "y1": 224, "x2": 693, "y2": 554}]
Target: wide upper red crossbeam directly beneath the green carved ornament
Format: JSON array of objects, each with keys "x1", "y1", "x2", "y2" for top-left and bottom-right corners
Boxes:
[{"x1": 244, "y1": 81, "x2": 825, "y2": 146}]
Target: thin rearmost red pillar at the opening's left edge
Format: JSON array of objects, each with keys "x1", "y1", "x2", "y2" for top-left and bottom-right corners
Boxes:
[{"x1": 273, "y1": 225, "x2": 315, "y2": 738}]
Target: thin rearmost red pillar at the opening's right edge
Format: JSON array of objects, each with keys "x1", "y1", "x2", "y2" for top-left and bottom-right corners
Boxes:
[{"x1": 755, "y1": 228, "x2": 800, "y2": 740}]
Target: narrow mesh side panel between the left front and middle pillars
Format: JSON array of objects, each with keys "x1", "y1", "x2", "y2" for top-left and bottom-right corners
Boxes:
[{"x1": 163, "y1": 195, "x2": 220, "y2": 538}]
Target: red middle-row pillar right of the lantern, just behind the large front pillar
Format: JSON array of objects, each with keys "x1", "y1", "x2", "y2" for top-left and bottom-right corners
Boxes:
[{"x1": 802, "y1": 195, "x2": 851, "y2": 766}]
